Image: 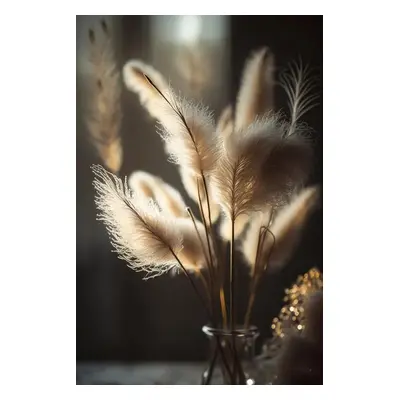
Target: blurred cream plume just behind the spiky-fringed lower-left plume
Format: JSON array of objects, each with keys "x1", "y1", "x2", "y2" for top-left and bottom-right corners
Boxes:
[{"x1": 128, "y1": 171, "x2": 188, "y2": 218}]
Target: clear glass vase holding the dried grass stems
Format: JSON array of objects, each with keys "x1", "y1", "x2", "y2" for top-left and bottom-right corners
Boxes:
[{"x1": 201, "y1": 325, "x2": 259, "y2": 385}]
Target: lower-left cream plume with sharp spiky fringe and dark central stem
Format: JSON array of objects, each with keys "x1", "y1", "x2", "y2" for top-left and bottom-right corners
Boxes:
[{"x1": 92, "y1": 166, "x2": 183, "y2": 279}]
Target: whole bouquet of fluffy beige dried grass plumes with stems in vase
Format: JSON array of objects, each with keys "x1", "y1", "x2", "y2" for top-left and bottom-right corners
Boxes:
[{"x1": 93, "y1": 48, "x2": 318, "y2": 384}]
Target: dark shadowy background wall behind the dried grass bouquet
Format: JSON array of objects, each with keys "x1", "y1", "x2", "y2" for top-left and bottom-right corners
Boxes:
[{"x1": 76, "y1": 16, "x2": 323, "y2": 360}]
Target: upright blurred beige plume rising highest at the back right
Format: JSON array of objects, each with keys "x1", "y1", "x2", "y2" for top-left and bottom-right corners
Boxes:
[{"x1": 235, "y1": 47, "x2": 274, "y2": 131}]
